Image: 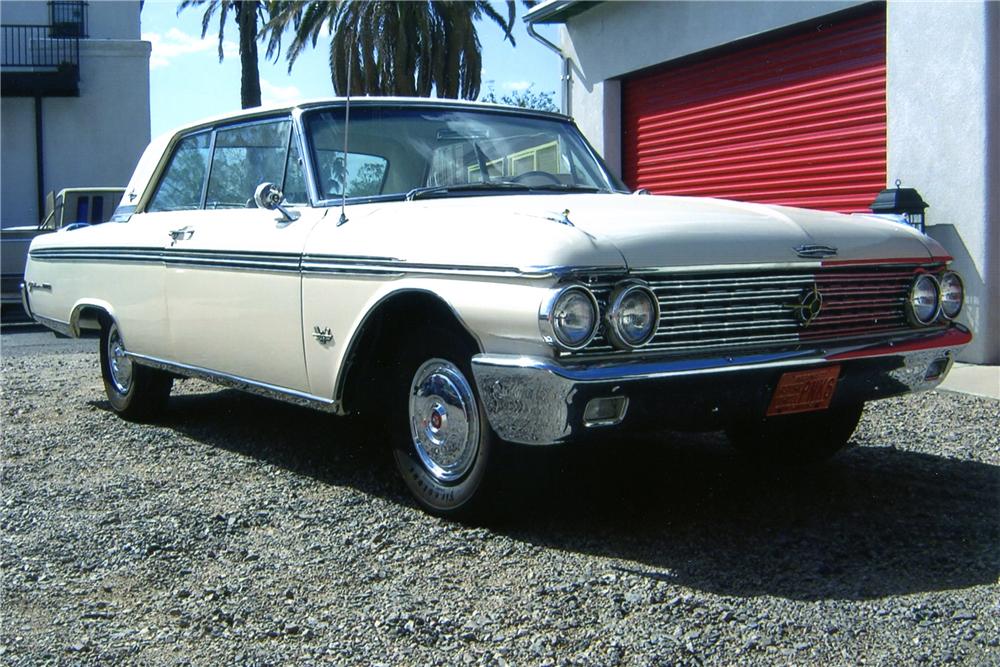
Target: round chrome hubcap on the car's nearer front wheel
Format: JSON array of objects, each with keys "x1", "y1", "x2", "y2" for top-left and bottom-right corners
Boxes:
[{"x1": 410, "y1": 359, "x2": 479, "y2": 482}]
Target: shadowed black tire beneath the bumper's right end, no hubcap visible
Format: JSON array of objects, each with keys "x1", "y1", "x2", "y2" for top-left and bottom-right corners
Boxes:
[{"x1": 726, "y1": 403, "x2": 864, "y2": 465}]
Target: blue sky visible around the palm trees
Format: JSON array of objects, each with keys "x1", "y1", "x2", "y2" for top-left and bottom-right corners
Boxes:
[{"x1": 142, "y1": 0, "x2": 559, "y2": 137}]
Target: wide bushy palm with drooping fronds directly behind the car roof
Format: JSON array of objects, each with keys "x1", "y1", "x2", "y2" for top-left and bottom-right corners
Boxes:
[{"x1": 265, "y1": 0, "x2": 515, "y2": 99}]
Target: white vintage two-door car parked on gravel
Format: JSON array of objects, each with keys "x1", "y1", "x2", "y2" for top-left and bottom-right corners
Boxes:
[{"x1": 22, "y1": 98, "x2": 972, "y2": 516}]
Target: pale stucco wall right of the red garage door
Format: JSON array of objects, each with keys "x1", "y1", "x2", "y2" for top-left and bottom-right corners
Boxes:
[{"x1": 886, "y1": 2, "x2": 1000, "y2": 364}]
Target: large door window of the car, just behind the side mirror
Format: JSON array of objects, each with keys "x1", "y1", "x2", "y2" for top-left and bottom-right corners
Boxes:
[{"x1": 205, "y1": 120, "x2": 292, "y2": 209}]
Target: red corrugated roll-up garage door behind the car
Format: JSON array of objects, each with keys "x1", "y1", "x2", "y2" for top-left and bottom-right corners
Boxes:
[{"x1": 622, "y1": 11, "x2": 886, "y2": 212}]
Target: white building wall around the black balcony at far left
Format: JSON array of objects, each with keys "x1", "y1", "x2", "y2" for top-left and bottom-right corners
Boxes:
[{"x1": 0, "y1": 0, "x2": 150, "y2": 227}]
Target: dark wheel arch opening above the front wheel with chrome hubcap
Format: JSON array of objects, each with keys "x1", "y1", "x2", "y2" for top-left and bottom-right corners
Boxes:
[{"x1": 333, "y1": 288, "x2": 483, "y2": 412}]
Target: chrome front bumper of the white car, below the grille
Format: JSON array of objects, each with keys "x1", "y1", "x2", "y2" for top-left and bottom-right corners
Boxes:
[{"x1": 472, "y1": 325, "x2": 972, "y2": 445}]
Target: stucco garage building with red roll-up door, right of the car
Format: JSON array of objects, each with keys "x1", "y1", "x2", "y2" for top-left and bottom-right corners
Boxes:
[{"x1": 525, "y1": 0, "x2": 1000, "y2": 364}]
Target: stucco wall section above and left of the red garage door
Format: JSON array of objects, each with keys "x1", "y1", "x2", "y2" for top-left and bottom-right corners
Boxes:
[{"x1": 561, "y1": 0, "x2": 862, "y2": 176}]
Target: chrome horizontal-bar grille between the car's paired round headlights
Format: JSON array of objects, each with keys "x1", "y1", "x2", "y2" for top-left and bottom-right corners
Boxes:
[{"x1": 573, "y1": 265, "x2": 932, "y2": 357}]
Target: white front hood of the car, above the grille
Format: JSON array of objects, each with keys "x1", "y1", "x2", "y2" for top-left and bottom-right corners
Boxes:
[{"x1": 324, "y1": 194, "x2": 944, "y2": 271}]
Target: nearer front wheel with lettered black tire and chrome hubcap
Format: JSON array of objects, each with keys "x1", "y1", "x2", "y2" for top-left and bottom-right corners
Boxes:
[{"x1": 391, "y1": 337, "x2": 502, "y2": 519}]
